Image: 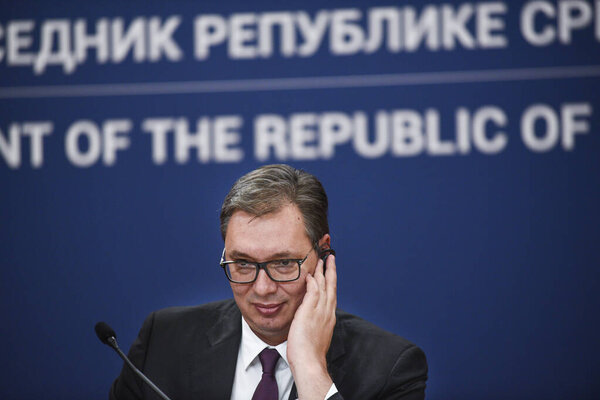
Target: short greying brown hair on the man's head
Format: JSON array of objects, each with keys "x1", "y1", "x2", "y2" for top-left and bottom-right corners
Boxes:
[{"x1": 221, "y1": 164, "x2": 329, "y2": 246}]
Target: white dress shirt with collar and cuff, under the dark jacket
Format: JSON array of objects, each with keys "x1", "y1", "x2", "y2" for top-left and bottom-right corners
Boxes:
[{"x1": 231, "y1": 317, "x2": 337, "y2": 400}]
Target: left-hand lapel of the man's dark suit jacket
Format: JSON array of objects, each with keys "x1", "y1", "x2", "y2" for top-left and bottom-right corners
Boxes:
[{"x1": 190, "y1": 301, "x2": 242, "y2": 400}]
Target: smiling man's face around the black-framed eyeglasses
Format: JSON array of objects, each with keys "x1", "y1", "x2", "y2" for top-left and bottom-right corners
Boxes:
[{"x1": 225, "y1": 205, "x2": 317, "y2": 345}]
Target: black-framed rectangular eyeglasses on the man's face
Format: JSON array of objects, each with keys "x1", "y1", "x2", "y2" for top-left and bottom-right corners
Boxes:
[{"x1": 219, "y1": 249, "x2": 313, "y2": 283}]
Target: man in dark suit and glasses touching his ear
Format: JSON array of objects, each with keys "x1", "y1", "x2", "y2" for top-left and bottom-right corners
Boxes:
[{"x1": 110, "y1": 165, "x2": 427, "y2": 400}]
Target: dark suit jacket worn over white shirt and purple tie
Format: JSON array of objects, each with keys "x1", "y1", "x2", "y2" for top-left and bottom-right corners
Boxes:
[{"x1": 109, "y1": 300, "x2": 427, "y2": 400}]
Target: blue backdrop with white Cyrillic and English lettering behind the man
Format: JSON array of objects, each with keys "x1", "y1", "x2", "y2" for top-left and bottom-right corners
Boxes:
[{"x1": 0, "y1": 0, "x2": 600, "y2": 399}]
